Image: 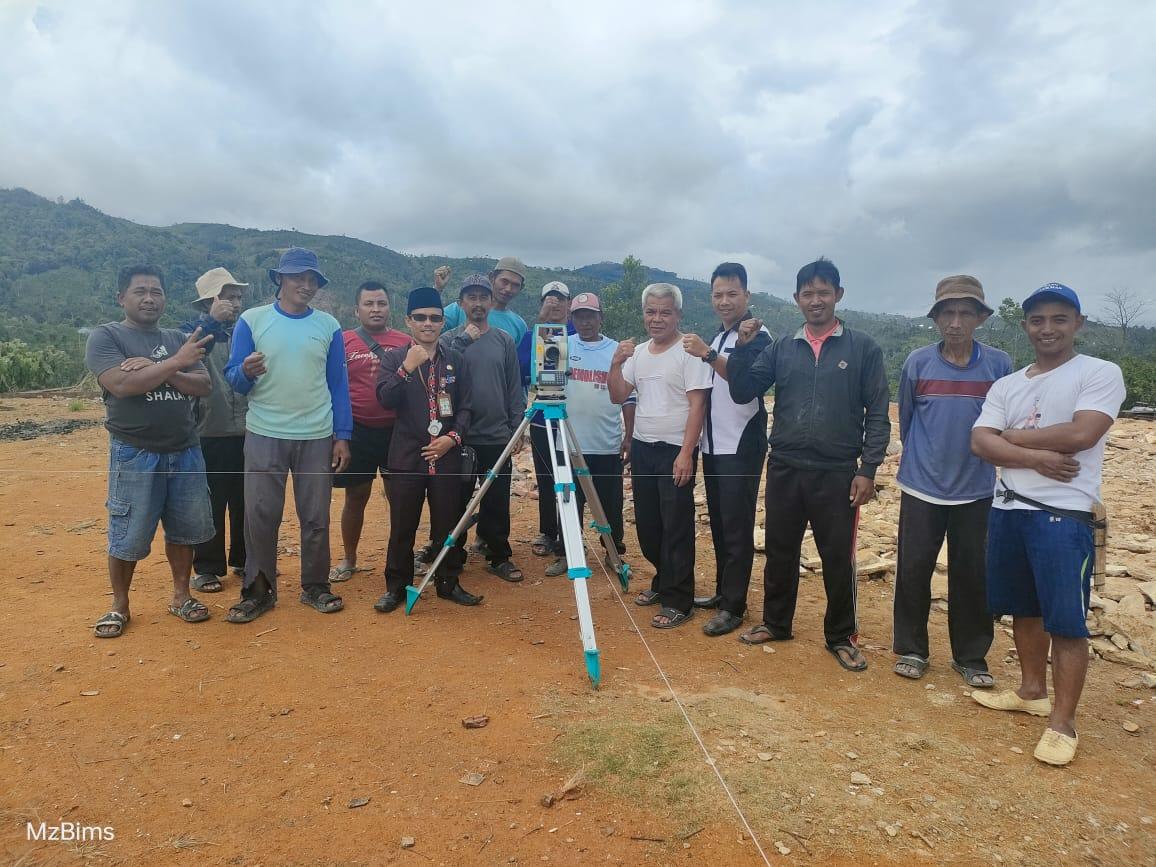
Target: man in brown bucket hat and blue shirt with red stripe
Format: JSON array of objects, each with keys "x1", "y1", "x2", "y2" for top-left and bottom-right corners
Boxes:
[{"x1": 892, "y1": 275, "x2": 1012, "y2": 689}]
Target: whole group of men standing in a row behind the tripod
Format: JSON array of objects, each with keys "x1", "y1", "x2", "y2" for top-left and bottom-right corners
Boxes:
[{"x1": 87, "y1": 247, "x2": 1124, "y2": 765}]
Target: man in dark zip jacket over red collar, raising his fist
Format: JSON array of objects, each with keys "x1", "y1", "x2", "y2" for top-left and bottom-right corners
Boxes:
[{"x1": 727, "y1": 259, "x2": 891, "y2": 672}]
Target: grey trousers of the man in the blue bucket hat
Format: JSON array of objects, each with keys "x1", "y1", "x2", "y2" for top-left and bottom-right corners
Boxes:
[{"x1": 242, "y1": 434, "x2": 333, "y2": 598}]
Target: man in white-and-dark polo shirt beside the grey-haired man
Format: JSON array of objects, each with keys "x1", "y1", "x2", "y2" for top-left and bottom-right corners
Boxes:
[{"x1": 682, "y1": 262, "x2": 771, "y2": 636}]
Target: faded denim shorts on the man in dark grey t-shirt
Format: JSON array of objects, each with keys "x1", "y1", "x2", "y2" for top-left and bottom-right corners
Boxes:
[{"x1": 106, "y1": 437, "x2": 216, "y2": 562}]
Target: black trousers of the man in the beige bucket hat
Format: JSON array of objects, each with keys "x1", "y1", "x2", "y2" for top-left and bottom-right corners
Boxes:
[{"x1": 193, "y1": 437, "x2": 245, "y2": 578}]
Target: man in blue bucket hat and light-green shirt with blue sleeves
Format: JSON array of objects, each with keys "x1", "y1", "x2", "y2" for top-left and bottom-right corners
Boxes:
[{"x1": 225, "y1": 247, "x2": 353, "y2": 623}]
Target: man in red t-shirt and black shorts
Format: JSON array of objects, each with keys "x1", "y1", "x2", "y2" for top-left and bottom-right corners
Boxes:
[{"x1": 329, "y1": 280, "x2": 413, "y2": 581}]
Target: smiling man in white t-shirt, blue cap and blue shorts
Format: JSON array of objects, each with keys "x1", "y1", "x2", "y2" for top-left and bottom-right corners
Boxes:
[{"x1": 971, "y1": 283, "x2": 1125, "y2": 765}]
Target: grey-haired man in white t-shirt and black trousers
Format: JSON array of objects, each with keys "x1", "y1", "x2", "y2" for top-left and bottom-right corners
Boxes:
[{"x1": 608, "y1": 283, "x2": 711, "y2": 629}]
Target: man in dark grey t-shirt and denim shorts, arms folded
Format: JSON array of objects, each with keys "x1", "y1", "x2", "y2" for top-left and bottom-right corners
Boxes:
[{"x1": 84, "y1": 265, "x2": 213, "y2": 638}]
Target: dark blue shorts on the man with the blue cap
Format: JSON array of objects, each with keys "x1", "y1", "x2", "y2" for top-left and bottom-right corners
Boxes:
[{"x1": 987, "y1": 509, "x2": 1095, "y2": 638}]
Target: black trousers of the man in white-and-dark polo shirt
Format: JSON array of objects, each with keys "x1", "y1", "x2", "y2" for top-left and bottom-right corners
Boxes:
[{"x1": 703, "y1": 447, "x2": 766, "y2": 617}]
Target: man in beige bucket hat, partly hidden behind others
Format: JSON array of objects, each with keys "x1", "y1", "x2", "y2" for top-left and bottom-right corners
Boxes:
[{"x1": 180, "y1": 268, "x2": 249, "y2": 593}]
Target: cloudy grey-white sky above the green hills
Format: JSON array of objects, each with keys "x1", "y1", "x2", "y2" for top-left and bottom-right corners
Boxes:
[{"x1": 0, "y1": 0, "x2": 1156, "y2": 321}]
